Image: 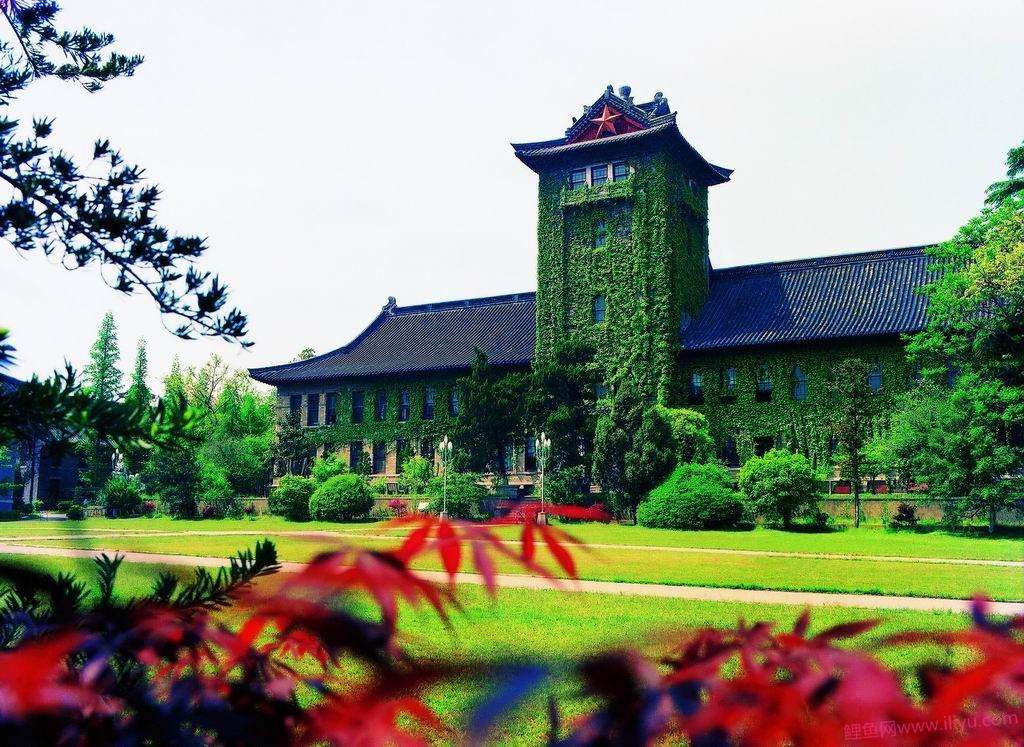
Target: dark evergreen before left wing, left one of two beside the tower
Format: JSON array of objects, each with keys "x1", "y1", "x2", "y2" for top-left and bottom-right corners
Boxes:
[{"x1": 452, "y1": 349, "x2": 527, "y2": 476}]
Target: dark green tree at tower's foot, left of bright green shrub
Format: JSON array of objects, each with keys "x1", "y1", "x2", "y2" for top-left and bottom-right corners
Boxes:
[{"x1": 593, "y1": 383, "x2": 676, "y2": 515}]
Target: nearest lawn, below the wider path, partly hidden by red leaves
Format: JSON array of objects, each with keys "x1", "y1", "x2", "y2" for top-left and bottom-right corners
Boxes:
[{"x1": 4, "y1": 556, "x2": 969, "y2": 744}]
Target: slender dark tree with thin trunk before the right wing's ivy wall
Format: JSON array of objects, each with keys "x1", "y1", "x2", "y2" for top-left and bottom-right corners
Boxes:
[{"x1": 830, "y1": 358, "x2": 879, "y2": 527}]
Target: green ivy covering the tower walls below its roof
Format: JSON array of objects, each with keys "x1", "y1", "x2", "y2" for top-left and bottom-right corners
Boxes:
[{"x1": 537, "y1": 147, "x2": 708, "y2": 403}]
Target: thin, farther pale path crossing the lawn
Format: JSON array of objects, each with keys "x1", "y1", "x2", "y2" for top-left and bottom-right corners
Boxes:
[{"x1": 0, "y1": 529, "x2": 1024, "y2": 569}]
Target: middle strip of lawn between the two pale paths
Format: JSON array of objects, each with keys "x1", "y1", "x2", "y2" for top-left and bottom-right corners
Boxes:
[{"x1": 9, "y1": 525, "x2": 1024, "y2": 601}]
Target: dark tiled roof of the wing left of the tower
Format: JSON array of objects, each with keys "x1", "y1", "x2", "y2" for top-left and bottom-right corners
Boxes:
[{"x1": 249, "y1": 293, "x2": 536, "y2": 384}]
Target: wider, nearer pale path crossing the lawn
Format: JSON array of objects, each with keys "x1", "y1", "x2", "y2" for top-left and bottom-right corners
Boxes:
[{"x1": 0, "y1": 544, "x2": 1024, "y2": 615}]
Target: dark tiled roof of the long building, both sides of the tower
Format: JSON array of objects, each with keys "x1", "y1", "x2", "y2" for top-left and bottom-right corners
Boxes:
[{"x1": 250, "y1": 247, "x2": 931, "y2": 384}]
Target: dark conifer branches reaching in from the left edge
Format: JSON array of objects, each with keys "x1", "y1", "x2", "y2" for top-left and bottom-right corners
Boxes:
[{"x1": 0, "y1": 0, "x2": 249, "y2": 469}]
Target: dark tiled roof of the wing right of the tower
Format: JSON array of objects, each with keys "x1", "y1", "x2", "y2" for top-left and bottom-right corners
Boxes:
[{"x1": 681, "y1": 247, "x2": 931, "y2": 350}]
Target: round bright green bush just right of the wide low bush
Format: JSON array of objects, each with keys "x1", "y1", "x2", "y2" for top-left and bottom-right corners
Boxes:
[{"x1": 739, "y1": 449, "x2": 818, "y2": 529}]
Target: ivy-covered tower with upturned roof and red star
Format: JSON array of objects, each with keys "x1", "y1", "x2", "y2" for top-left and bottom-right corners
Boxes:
[{"x1": 513, "y1": 85, "x2": 732, "y2": 403}]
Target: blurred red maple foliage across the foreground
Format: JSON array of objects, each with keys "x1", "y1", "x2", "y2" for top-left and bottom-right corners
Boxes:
[{"x1": 0, "y1": 506, "x2": 1024, "y2": 745}]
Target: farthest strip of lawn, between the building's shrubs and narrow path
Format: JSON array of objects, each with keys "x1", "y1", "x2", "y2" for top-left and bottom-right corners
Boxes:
[{"x1": 0, "y1": 516, "x2": 1024, "y2": 561}]
